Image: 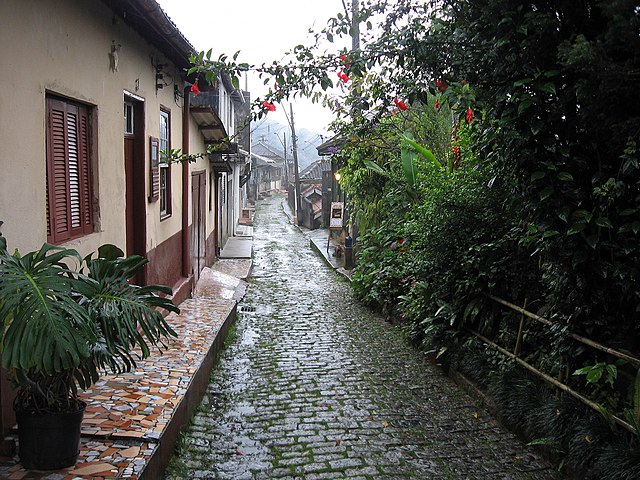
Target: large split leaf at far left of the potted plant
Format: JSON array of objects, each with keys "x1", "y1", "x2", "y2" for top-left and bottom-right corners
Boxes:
[{"x1": 0, "y1": 244, "x2": 96, "y2": 374}]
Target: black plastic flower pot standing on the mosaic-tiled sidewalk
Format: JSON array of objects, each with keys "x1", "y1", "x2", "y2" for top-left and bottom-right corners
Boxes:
[{"x1": 16, "y1": 404, "x2": 86, "y2": 470}]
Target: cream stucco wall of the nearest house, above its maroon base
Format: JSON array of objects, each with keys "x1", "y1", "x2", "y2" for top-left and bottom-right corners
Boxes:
[{"x1": 0, "y1": 0, "x2": 201, "y2": 262}]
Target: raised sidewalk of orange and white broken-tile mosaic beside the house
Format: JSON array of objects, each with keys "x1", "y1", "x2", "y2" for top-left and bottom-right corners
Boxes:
[{"x1": 0, "y1": 260, "x2": 251, "y2": 480}]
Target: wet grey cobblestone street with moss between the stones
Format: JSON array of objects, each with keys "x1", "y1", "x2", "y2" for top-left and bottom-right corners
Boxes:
[{"x1": 167, "y1": 198, "x2": 557, "y2": 480}]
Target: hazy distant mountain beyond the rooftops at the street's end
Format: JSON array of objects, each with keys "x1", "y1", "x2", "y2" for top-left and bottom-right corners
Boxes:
[{"x1": 251, "y1": 118, "x2": 327, "y2": 170}]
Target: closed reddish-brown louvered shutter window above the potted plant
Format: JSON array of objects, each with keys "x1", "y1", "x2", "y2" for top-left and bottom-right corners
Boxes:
[{"x1": 46, "y1": 97, "x2": 94, "y2": 243}]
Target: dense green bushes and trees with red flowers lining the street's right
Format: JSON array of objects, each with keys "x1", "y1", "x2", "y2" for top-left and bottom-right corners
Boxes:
[{"x1": 188, "y1": 0, "x2": 640, "y2": 472}]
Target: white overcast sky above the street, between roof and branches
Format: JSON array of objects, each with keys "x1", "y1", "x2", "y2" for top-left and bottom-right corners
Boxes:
[{"x1": 158, "y1": 0, "x2": 349, "y2": 132}]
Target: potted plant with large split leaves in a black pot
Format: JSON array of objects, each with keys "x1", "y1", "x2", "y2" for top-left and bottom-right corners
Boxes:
[{"x1": 0, "y1": 234, "x2": 179, "y2": 470}]
